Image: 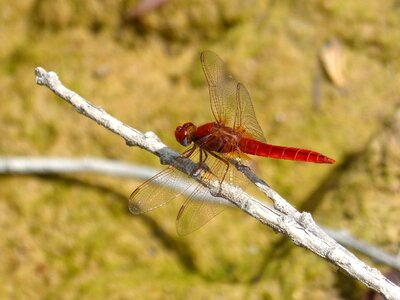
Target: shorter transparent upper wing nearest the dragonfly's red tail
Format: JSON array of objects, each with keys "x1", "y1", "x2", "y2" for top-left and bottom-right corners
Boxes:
[{"x1": 234, "y1": 83, "x2": 266, "y2": 142}]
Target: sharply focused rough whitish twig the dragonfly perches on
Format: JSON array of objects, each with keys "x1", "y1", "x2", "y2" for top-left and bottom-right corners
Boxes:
[{"x1": 35, "y1": 67, "x2": 400, "y2": 299}]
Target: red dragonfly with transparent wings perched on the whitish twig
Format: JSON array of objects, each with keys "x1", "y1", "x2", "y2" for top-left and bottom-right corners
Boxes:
[{"x1": 129, "y1": 51, "x2": 335, "y2": 235}]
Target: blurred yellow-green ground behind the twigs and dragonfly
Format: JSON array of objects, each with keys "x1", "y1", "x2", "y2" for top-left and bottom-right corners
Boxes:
[{"x1": 0, "y1": 0, "x2": 400, "y2": 299}]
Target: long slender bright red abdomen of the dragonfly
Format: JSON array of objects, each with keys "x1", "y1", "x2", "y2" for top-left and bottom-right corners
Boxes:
[{"x1": 239, "y1": 138, "x2": 335, "y2": 164}]
